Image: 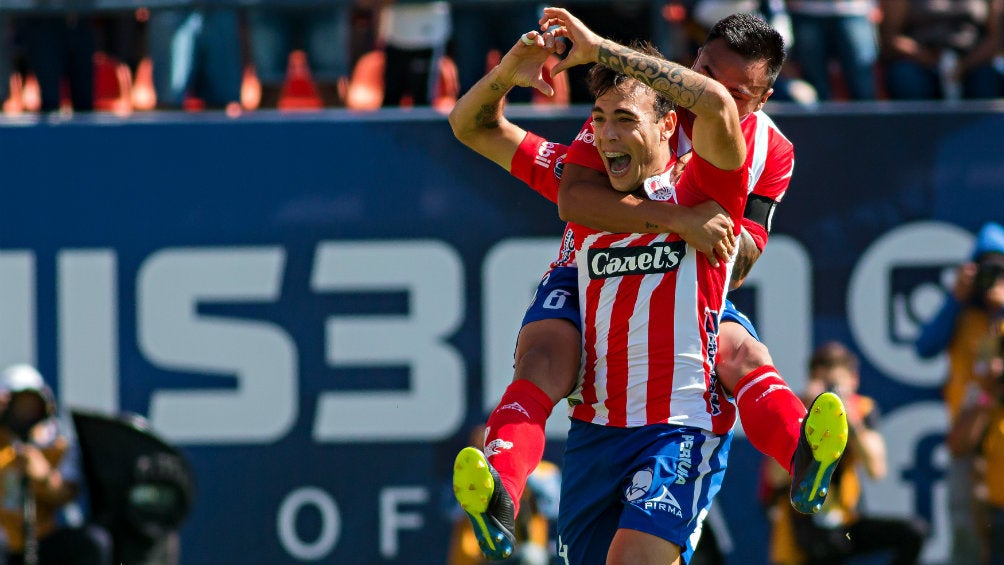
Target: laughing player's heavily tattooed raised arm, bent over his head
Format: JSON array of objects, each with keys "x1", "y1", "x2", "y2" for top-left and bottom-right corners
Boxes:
[{"x1": 540, "y1": 8, "x2": 746, "y2": 171}]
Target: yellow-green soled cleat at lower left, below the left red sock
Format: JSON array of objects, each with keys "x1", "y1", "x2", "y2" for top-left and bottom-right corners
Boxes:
[{"x1": 453, "y1": 448, "x2": 516, "y2": 561}]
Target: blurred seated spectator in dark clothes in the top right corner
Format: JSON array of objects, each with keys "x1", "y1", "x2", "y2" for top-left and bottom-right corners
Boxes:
[{"x1": 881, "y1": 0, "x2": 1004, "y2": 100}]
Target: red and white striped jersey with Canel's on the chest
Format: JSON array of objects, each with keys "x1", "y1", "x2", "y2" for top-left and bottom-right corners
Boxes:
[{"x1": 568, "y1": 149, "x2": 748, "y2": 434}]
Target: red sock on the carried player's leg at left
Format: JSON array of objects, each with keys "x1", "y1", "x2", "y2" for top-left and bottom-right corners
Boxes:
[{"x1": 485, "y1": 378, "x2": 553, "y2": 516}]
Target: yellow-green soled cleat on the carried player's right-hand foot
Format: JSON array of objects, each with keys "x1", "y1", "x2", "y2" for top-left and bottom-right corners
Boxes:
[{"x1": 790, "y1": 392, "x2": 847, "y2": 514}]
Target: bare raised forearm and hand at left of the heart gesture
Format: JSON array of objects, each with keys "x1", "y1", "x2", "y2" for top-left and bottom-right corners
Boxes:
[{"x1": 450, "y1": 31, "x2": 563, "y2": 171}]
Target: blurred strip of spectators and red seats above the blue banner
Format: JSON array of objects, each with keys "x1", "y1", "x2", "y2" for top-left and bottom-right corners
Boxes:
[{"x1": 0, "y1": 0, "x2": 1004, "y2": 114}]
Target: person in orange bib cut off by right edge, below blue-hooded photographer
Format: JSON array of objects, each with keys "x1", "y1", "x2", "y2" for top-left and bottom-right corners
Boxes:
[{"x1": 947, "y1": 320, "x2": 1004, "y2": 565}]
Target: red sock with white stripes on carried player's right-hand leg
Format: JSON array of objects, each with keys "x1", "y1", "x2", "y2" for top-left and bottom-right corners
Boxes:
[{"x1": 736, "y1": 365, "x2": 806, "y2": 473}]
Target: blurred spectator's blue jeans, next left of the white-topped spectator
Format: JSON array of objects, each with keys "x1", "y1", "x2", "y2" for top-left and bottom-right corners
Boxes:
[{"x1": 248, "y1": 0, "x2": 352, "y2": 108}]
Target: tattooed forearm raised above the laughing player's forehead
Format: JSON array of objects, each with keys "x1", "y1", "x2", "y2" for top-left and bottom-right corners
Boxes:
[{"x1": 598, "y1": 41, "x2": 708, "y2": 108}]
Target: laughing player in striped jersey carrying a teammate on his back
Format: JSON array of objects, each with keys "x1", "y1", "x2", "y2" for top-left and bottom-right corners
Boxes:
[{"x1": 542, "y1": 12, "x2": 749, "y2": 565}]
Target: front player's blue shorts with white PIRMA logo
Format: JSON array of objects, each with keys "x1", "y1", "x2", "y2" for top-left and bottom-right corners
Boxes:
[{"x1": 558, "y1": 419, "x2": 732, "y2": 565}]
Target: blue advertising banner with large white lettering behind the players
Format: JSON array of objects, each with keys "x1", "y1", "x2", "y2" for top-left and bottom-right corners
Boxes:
[{"x1": 0, "y1": 105, "x2": 1004, "y2": 565}]
